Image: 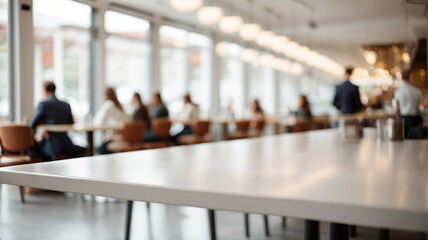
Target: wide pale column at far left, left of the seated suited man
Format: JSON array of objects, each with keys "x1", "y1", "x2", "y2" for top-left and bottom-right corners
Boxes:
[{"x1": 9, "y1": 0, "x2": 34, "y2": 121}]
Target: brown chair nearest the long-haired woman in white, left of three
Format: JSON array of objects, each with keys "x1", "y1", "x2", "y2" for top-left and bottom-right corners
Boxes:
[{"x1": 108, "y1": 121, "x2": 147, "y2": 152}]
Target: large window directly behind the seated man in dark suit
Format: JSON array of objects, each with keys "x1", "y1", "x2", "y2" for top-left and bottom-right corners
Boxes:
[{"x1": 33, "y1": 0, "x2": 91, "y2": 116}]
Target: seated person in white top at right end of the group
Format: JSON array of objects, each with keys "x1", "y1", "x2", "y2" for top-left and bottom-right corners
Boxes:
[{"x1": 173, "y1": 94, "x2": 199, "y2": 142}]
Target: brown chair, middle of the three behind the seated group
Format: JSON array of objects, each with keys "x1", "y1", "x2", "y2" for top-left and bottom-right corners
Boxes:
[{"x1": 142, "y1": 118, "x2": 172, "y2": 149}]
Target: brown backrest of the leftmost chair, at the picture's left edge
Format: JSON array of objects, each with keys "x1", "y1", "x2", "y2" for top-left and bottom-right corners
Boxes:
[{"x1": 0, "y1": 124, "x2": 33, "y2": 153}]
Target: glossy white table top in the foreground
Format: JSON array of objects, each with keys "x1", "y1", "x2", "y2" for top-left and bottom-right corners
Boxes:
[{"x1": 0, "y1": 130, "x2": 428, "y2": 231}]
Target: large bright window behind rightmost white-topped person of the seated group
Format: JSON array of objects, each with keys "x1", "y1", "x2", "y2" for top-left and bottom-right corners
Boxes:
[{"x1": 160, "y1": 26, "x2": 211, "y2": 116}]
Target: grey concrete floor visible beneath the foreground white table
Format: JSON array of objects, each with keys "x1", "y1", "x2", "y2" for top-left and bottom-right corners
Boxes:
[{"x1": 0, "y1": 185, "x2": 426, "y2": 240}]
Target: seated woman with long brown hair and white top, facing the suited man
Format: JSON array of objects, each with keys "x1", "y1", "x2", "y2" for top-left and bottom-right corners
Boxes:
[{"x1": 94, "y1": 88, "x2": 128, "y2": 154}]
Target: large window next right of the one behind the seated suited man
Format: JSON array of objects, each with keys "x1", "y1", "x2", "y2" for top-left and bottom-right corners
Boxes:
[{"x1": 105, "y1": 11, "x2": 151, "y2": 107}]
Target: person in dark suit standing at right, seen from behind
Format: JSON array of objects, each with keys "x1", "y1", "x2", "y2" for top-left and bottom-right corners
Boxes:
[{"x1": 333, "y1": 68, "x2": 363, "y2": 114}]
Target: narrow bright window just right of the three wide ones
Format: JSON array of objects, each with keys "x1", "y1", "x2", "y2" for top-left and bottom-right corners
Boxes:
[{"x1": 219, "y1": 43, "x2": 245, "y2": 117}]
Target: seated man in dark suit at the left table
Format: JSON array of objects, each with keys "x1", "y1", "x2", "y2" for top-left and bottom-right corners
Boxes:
[{"x1": 30, "y1": 82, "x2": 86, "y2": 161}]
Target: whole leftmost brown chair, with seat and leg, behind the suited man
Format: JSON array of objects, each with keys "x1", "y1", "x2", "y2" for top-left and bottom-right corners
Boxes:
[{"x1": 0, "y1": 124, "x2": 40, "y2": 203}]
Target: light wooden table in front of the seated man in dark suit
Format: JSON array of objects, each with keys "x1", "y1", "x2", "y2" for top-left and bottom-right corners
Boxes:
[{"x1": 37, "y1": 123, "x2": 122, "y2": 156}]
